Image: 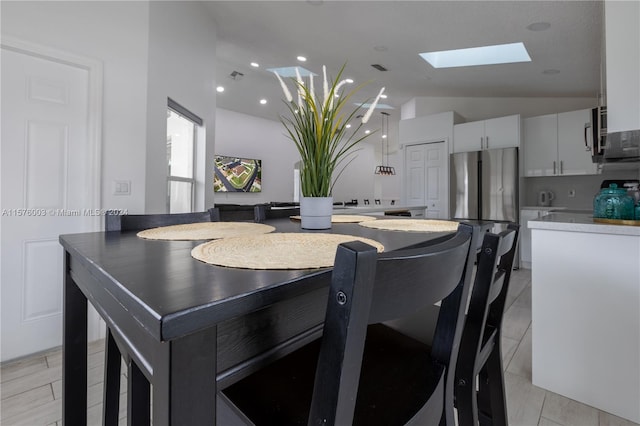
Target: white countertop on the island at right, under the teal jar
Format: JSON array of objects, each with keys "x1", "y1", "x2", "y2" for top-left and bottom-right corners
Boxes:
[{"x1": 528, "y1": 212, "x2": 640, "y2": 236}]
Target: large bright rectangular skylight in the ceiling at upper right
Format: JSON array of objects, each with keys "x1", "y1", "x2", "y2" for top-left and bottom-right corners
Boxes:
[{"x1": 420, "y1": 43, "x2": 531, "y2": 68}]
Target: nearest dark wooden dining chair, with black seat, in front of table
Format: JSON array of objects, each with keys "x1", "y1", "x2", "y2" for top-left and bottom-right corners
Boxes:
[{"x1": 220, "y1": 224, "x2": 475, "y2": 426}]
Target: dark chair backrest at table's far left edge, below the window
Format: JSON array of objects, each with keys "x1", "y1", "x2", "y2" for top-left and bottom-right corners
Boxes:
[{"x1": 105, "y1": 209, "x2": 218, "y2": 231}]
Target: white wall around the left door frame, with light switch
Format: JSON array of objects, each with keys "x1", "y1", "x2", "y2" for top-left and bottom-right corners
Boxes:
[{"x1": 1, "y1": 1, "x2": 149, "y2": 213}]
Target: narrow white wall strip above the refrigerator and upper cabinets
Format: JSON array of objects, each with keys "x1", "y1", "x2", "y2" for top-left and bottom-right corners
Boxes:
[{"x1": 402, "y1": 94, "x2": 598, "y2": 121}]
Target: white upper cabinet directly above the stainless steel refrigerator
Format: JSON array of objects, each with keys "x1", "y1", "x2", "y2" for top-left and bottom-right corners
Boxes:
[{"x1": 453, "y1": 115, "x2": 520, "y2": 152}]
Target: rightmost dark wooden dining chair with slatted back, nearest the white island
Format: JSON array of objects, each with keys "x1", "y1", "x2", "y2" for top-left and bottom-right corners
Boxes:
[{"x1": 455, "y1": 224, "x2": 520, "y2": 426}]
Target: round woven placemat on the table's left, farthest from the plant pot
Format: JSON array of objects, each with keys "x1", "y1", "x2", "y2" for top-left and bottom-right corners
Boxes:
[{"x1": 138, "y1": 222, "x2": 276, "y2": 241}]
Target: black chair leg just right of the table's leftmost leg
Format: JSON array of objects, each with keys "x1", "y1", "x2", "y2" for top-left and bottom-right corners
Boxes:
[{"x1": 102, "y1": 327, "x2": 121, "y2": 426}]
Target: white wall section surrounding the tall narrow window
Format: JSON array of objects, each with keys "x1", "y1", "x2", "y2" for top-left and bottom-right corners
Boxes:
[{"x1": 145, "y1": 1, "x2": 216, "y2": 213}]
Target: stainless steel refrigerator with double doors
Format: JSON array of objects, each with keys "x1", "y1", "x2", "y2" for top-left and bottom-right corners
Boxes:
[{"x1": 449, "y1": 148, "x2": 519, "y2": 222}]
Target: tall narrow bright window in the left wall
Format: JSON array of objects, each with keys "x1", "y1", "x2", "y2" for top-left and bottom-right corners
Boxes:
[{"x1": 167, "y1": 99, "x2": 202, "y2": 213}]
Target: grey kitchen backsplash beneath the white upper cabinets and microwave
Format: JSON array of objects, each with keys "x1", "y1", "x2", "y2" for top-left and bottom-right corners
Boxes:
[{"x1": 523, "y1": 169, "x2": 640, "y2": 210}]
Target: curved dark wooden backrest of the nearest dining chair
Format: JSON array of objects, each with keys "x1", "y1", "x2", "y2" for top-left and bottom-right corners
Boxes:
[{"x1": 309, "y1": 225, "x2": 475, "y2": 424}]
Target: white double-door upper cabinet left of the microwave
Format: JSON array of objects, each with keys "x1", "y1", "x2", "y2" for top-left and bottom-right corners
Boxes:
[{"x1": 523, "y1": 109, "x2": 598, "y2": 176}]
